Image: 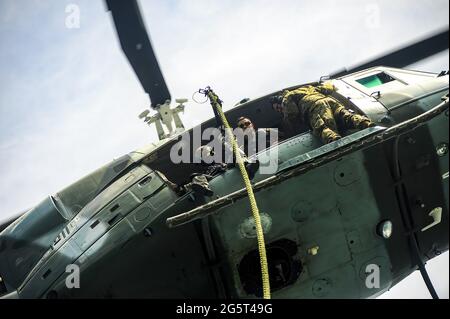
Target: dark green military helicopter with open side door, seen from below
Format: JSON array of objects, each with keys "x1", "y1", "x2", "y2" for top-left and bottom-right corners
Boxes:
[{"x1": 0, "y1": 1, "x2": 448, "y2": 298}]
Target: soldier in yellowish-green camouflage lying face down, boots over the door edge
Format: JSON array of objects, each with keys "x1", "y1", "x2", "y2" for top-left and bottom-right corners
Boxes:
[{"x1": 271, "y1": 82, "x2": 375, "y2": 144}]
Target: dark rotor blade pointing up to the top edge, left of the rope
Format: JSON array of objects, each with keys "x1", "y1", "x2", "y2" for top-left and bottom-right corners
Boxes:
[{"x1": 106, "y1": 0, "x2": 171, "y2": 107}]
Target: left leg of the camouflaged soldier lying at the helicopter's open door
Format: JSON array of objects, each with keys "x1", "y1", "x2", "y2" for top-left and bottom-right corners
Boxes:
[{"x1": 309, "y1": 104, "x2": 341, "y2": 144}]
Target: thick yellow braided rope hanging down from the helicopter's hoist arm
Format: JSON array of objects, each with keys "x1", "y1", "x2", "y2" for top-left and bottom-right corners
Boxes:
[{"x1": 207, "y1": 90, "x2": 270, "y2": 299}]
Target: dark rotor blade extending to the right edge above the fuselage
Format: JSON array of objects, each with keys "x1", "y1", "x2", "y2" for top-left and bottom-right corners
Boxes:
[{"x1": 330, "y1": 28, "x2": 449, "y2": 78}]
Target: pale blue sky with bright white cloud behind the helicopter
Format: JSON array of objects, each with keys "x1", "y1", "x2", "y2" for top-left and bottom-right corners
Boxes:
[{"x1": 0, "y1": 0, "x2": 449, "y2": 298}]
